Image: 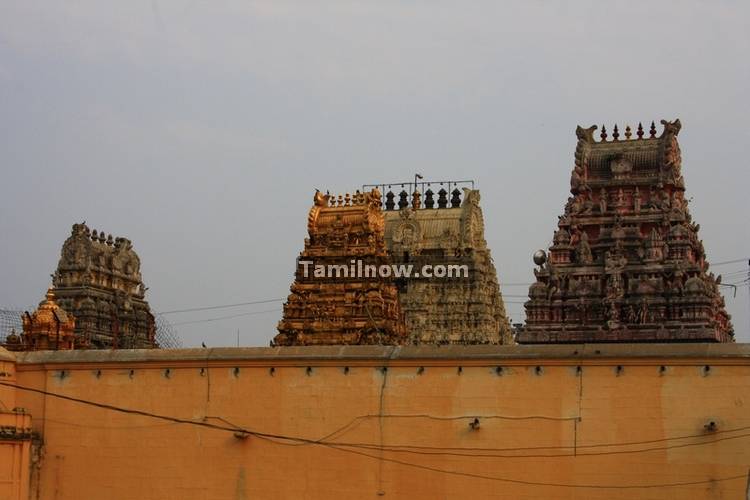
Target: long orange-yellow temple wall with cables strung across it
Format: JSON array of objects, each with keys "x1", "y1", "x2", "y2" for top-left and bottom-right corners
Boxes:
[{"x1": 0, "y1": 344, "x2": 750, "y2": 500}]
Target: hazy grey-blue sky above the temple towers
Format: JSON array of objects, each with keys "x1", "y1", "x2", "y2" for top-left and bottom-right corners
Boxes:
[{"x1": 0, "y1": 0, "x2": 750, "y2": 346}]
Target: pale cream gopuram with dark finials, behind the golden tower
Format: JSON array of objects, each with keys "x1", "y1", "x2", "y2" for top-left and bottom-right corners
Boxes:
[{"x1": 382, "y1": 179, "x2": 513, "y2": 344}]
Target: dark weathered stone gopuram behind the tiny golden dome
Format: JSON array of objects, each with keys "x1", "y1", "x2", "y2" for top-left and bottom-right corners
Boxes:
[{"x1": 53, "y1": 223, "x2": 156, "y2": 349}]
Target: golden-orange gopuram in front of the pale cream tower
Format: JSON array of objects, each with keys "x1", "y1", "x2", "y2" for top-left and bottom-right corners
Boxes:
[{"x1": 271, "y1": 189, "x2": 405, "y2": 345}]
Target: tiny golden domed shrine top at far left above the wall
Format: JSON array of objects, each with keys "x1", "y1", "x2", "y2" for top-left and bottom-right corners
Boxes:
[{"x1": 3, "y1": 288, "x2": 76, "y2": 351}]
